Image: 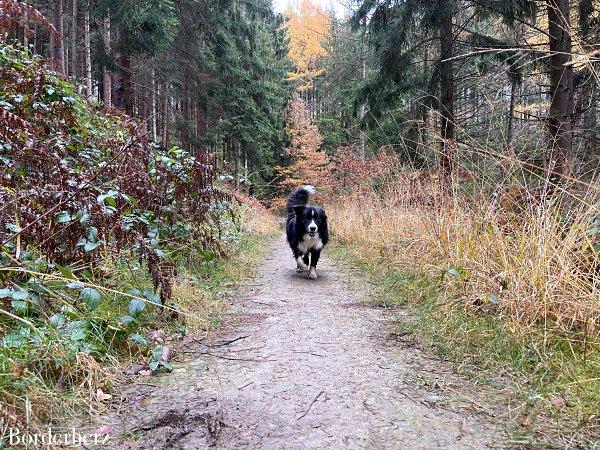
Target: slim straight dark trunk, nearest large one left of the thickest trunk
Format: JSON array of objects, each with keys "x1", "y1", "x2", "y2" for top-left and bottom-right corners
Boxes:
[{"x1": 438, "y1": 0, "x2": 455, "y2": 189}]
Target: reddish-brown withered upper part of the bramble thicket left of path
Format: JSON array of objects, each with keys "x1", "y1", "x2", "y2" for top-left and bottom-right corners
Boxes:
[{"x1": 0, "y1": 46, "x2": 221, "y2": 301}]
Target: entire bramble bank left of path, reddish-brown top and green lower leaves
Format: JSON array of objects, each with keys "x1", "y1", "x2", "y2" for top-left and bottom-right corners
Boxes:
[{"x1": 0, "y1": 45, "x2": 233, "y2": 425}]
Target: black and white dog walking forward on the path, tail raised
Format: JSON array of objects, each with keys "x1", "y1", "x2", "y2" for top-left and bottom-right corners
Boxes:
[{"x1": 285, "y1": 186, "x2": 329, "y2": 279}]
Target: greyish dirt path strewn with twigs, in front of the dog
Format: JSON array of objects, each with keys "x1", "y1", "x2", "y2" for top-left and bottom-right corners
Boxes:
[{"x1": 103, "y1": 239, "x2": 501, "y2": 449}]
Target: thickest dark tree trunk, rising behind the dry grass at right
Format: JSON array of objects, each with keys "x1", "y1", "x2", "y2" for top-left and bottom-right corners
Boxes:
[{"x1": 546, "y1": 0, "x2": 573, "y2": 186}]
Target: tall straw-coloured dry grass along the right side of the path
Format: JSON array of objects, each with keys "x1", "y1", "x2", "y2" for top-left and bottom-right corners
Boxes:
[{"x1": 328, "y1": 174, "x2": 600, "y2": 343}]
